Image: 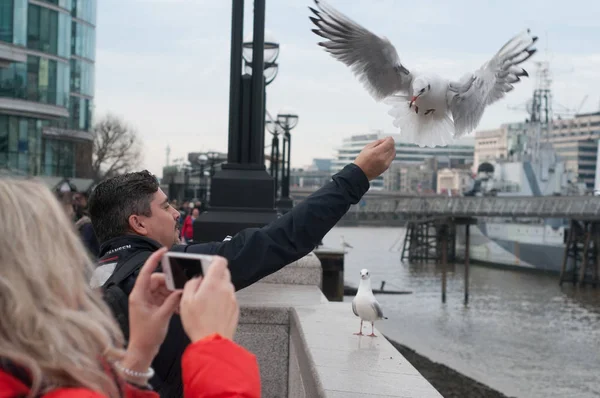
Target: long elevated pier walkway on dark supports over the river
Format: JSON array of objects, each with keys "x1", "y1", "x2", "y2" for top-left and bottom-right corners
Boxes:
[{"x1": 296, "y1": 190, "x2": 600, "y2": 304}]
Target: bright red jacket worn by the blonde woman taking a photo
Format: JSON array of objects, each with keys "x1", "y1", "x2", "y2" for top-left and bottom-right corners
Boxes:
[{"x1": 0, "y1": 335, "x2": 260, "y2": 398}]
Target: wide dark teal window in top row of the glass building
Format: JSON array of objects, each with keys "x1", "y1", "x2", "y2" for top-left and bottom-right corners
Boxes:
[{"x1": 27, "y1": 4, "x2": 71, "y2": 58}]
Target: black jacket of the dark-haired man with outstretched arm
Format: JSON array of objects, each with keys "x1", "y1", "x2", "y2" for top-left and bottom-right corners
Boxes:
[{"x1": 95, "y1": 164, "x2": 369, "y2": 397}]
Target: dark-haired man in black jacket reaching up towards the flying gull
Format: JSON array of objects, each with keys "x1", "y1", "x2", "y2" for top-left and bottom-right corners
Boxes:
[{"x1": 89, "y1": 137, "x2": 396, "y2": 397}]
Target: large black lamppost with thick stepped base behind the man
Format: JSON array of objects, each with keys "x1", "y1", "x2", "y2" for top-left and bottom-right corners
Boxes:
[{"x1": 194, "y1": 0, "x2": 278, "y2": 242}]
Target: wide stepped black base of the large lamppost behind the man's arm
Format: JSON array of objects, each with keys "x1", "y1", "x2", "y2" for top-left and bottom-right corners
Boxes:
[{"x1": 193, "y1": 164, "x2": 277, "y2": 243}]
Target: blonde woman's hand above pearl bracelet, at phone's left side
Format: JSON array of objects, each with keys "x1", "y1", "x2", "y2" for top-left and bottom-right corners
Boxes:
[{"x1": 121, "y1": 248, "x2": 182, "y2": 372}]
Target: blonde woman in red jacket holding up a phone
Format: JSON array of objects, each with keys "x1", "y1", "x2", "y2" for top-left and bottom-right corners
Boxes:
[{"x1": 0, "y1": 179, "x2": 260, "y2": 398}]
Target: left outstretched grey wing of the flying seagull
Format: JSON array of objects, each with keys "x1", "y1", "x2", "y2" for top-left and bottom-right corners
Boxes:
[{"x1": 309, "y1": 0, "x2": 412, "y2": 100}]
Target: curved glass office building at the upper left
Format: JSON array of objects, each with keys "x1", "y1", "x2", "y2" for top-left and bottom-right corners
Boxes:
[{"x1": 0, "y1": 0, "x2": 96, "y2": 178}]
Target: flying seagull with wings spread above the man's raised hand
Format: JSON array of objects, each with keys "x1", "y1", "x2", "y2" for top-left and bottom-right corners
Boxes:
[{"x1": 309, "y1": 0, "x2": 537, "y2": 147}]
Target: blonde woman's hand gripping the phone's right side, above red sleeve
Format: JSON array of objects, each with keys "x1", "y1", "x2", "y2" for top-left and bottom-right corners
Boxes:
[{"x1": 180, "y1": 256, "x2": 240, "y2": 342}]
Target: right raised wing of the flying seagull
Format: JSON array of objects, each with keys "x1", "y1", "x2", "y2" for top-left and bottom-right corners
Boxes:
[{"x1": 448, "y1": 30, "x2": 537, "y2": 137}]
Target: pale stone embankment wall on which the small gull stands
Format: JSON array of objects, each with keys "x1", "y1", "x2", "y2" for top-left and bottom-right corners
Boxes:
[{"x1": 235, "y1": 254, "x2": 441, "y2": 398}]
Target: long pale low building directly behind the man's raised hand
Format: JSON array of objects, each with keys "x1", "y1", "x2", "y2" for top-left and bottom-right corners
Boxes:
[{"x1": 332, "y1": 132, "x2": 474, "y2": 189}]
